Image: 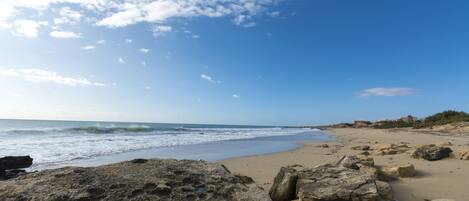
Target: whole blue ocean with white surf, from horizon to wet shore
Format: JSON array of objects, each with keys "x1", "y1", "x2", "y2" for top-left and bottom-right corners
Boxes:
[{"x1": 0, "y1": 120, "x2": 330, "y2": 170}]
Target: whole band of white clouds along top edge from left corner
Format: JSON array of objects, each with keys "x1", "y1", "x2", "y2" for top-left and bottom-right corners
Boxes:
[{"x1": 0, "y1": 0, "x2": 281, "y2": 35}]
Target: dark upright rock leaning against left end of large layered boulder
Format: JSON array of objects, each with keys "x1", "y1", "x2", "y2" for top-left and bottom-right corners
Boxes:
[{"x1": 269, "y1": 167, "x2": 298, "y2": 201}]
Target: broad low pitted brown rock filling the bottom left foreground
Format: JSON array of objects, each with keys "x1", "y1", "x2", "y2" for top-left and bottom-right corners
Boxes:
[{"x1": 0, "y1": 159, "x2": 271, "y2": 201}]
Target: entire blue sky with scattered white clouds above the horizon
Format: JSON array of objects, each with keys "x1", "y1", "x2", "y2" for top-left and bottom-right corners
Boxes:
[{"x1": 0, "y1": 0, "x2": 469, "y2": 125}]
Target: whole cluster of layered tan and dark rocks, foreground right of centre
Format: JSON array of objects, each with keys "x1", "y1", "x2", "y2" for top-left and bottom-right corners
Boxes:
[{"x1": 270, "y1": 157, "x2": 393, "y2": 201}]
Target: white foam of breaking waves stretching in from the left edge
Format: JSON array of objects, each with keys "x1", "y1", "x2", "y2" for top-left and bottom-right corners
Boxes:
[{"x1": 0, "y1": 128, "x2": 314, "y2": 165}]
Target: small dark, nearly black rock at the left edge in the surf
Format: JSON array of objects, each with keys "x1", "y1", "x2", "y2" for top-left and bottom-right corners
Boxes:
[{"x1": 0, "y1": 156, "x2": 33, "y2": 180}]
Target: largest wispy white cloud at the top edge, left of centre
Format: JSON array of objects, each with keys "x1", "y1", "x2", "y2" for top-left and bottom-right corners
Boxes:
[{"x1": 97, "y1": 0, "x2": 270, "y2": 28}]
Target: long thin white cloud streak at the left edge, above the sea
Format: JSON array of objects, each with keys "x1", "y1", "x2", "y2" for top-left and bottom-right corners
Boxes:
[{"x1": 0, "y1": 68, "x2": 105, "y2": 87}]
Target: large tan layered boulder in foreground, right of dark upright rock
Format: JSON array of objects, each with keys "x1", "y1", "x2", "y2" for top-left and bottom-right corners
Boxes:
[{"x1": 296, "y1": 164, "x2": 394, "y2": 201}]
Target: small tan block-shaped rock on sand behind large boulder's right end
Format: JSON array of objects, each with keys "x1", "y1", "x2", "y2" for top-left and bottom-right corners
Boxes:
[{"x1": 377, "y1": 164, "x2": 415, "y2": 181}]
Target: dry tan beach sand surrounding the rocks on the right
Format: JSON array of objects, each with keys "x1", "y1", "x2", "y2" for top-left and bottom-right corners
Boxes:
[{"x1": 220, "y1": 128, "x2": 469, "y2": 201}]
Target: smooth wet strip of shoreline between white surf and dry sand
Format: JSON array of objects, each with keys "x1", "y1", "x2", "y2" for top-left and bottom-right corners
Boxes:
[{"x1": 27, "y1": 130, "x2": 330, "y2": 171}]
